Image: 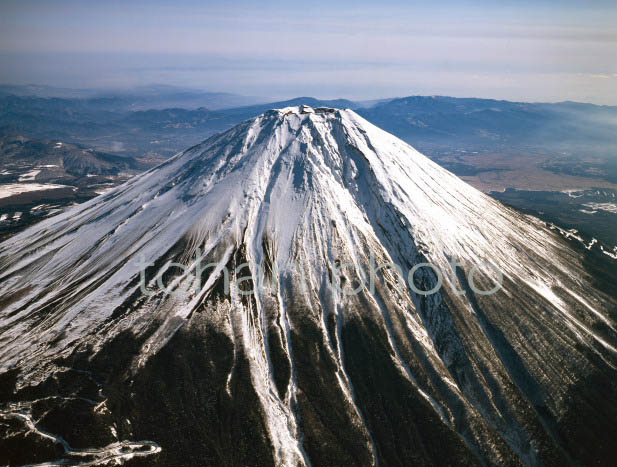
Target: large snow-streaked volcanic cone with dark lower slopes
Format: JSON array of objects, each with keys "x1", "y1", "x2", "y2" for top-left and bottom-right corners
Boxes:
[{"x1": 0, "y1": 106, "x2": 617, "y2": 466}]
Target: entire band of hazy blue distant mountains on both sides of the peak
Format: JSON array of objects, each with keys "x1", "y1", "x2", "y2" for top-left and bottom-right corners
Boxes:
[{"x1": 0, "y1": 86, "x2": 617, "y2": 162}]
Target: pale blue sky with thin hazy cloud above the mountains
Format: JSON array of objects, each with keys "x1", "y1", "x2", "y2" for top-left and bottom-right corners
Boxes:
[{"x1": 0, "y1": 0, "x2": 617, "y2": 104}]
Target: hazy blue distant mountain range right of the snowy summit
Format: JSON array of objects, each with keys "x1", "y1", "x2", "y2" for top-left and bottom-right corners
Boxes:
[{"x1": 358, "y1": 96, "x2": 617, "y2": 154}]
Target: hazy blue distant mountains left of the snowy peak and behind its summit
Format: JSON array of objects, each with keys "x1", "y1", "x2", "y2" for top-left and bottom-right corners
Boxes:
[{"x1": 0, "y1": 95, "x2": 366, "y2": 157}]
